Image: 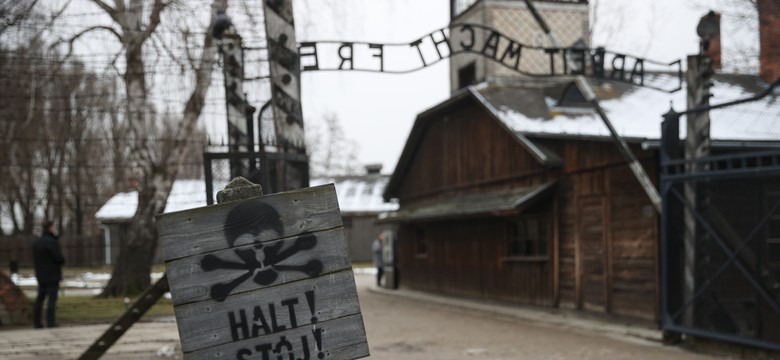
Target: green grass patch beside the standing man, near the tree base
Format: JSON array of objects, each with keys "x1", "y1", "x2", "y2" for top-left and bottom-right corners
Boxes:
[{"x1": 29, "y1": 296, "x2": 174, "y2": 325}]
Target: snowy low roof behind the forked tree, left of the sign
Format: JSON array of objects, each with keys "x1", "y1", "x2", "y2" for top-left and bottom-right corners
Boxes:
[{"x1": 95, "y1": 179, "x2": 220, "y2": 221}]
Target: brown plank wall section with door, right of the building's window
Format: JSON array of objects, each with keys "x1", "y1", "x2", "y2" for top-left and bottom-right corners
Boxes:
[{"x1": 558, "y1": 141, "x2": 659, "y2": 320}]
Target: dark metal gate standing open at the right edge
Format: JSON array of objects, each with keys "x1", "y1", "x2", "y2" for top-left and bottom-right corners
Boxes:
[{"x1": 660, "y1": 81, "x2": 780, "y2": 351}]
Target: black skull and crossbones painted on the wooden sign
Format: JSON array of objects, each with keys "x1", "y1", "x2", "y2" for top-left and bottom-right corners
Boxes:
[{"x1": 200, "y1": 200, "x2": 322, "y2": 301}]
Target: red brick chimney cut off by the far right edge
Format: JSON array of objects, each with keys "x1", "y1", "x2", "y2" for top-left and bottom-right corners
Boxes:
[{"x1": 757, "y1": 0, "x2": 780, "y2": 83}]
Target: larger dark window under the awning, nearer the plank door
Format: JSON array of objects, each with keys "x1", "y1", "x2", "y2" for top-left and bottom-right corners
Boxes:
[{"x1": 507, "y1": 214, "x2": 551, "y2": 258}]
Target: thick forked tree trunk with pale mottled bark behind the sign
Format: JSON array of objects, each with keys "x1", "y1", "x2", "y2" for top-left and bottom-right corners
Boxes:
[{"x1": 100, "y1": 0, "x2": 222, "y2": 297}]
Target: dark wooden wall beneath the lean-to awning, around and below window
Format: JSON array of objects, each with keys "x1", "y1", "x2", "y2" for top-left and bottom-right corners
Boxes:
[{"x1": 398, "y1": 218, "x2": 554, "y2": 306}]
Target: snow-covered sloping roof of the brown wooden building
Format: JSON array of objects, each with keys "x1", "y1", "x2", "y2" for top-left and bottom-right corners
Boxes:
[{"x1": 478, "y1": 75, "x2": 780, "y2": 141}]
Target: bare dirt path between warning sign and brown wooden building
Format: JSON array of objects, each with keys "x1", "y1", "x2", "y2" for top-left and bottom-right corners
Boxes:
[{"x1": 356, "y1": 275, "x2": 712, "y2": 360}]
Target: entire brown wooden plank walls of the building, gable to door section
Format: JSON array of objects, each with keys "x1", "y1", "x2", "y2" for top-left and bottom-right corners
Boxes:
[{"x1": 398, "y1": 97, "x2": 659, "y2": 320}]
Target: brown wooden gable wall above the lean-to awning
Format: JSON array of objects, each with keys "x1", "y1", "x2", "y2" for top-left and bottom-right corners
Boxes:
[{"x1": 399, "y1": 106, "x2": 555, "y2": 206}]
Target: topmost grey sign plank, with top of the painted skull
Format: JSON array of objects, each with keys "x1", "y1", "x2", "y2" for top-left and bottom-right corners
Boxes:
[{"x1": 157, "y1": 184, "x2": 342, "y2": 261}]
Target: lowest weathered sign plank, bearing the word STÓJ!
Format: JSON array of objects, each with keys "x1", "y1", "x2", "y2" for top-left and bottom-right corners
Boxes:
[{"x1": 185, "y1": 315, "x2": 369, "y2": 360}]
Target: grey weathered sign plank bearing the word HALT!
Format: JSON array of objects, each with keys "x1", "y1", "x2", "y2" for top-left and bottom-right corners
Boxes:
[{"x1": 176, "y1": 269, "x2": 360, "y2": 353}]
